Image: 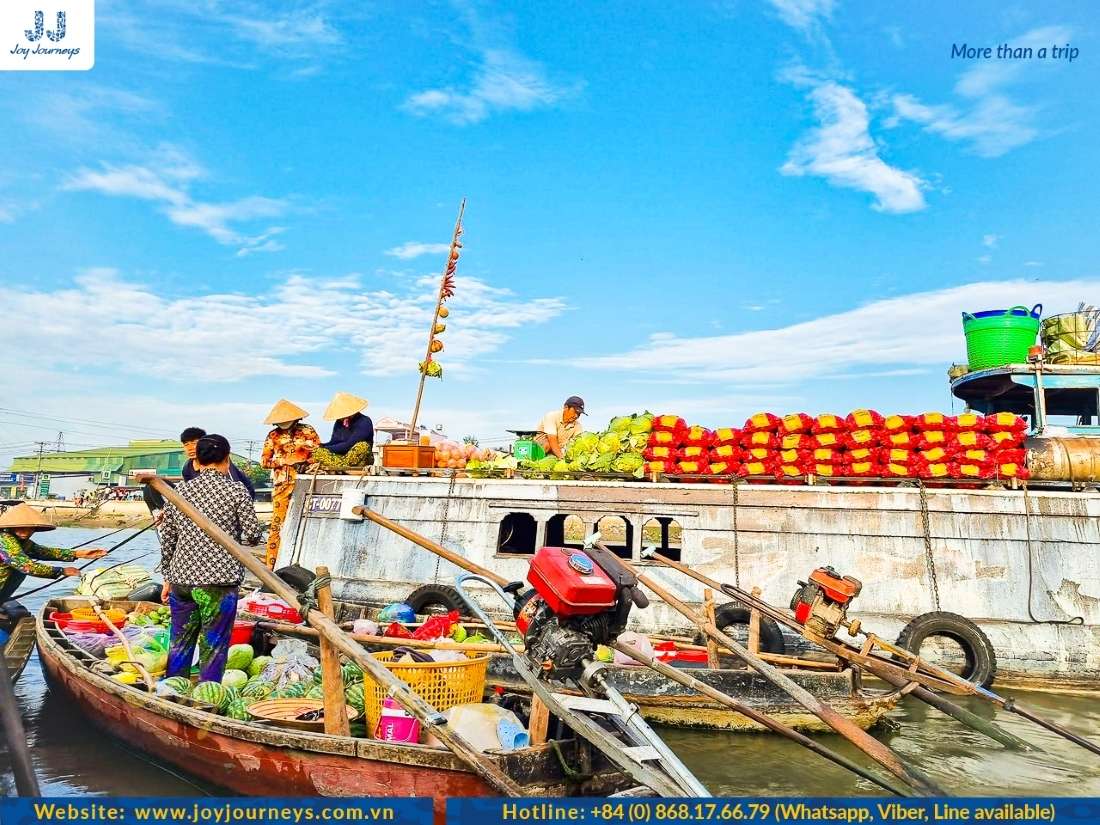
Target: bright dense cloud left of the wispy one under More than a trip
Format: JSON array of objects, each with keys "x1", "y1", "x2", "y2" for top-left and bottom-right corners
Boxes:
[{"x1": 780, "y1": 83, "x2": 926, "y2": 213}]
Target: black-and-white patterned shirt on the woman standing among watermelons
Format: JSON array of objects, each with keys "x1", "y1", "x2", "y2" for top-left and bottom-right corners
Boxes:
[{"x1": 160, "y1": 470, "x2": 263, "y2": 586}]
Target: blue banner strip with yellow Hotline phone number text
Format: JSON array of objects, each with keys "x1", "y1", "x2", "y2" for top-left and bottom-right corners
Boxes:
[{"x1": 447, "y1": 796, "x2": 1100, "y2": 825}]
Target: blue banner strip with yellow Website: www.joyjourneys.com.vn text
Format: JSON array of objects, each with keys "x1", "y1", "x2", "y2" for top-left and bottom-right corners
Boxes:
[{"x1": 0, "y1": 796, "x2": 432, "y2": 825}]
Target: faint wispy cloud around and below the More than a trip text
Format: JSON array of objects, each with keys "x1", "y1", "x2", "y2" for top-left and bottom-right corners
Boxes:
[{"x1": 887, "y1": 26, "x2": 1073, "y2": 157}]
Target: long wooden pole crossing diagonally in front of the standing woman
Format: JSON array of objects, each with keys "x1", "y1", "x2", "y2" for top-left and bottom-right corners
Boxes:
[{"x1": 141, "y1": 476, "x2": 525, "y2": 796}]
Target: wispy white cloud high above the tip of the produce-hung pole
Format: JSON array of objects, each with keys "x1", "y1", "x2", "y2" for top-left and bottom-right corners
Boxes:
[{"x1": 404, "y1": 48, "x2": 579, "y2": 125}]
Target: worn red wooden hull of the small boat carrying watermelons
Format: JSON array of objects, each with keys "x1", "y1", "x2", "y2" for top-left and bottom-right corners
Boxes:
[{"x1": 36, "y1": 597, "x2": 635, "y2": 823}]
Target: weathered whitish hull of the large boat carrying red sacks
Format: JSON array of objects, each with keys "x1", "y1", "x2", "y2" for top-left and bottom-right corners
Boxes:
[{"x1": 281, "y1": 476, "x2": 1100, "y2": 689}]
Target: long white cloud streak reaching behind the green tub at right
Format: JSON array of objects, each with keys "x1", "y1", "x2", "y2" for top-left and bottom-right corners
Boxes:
[{"x1": 576, "y1": 277, "x2": 1086, "y2": 386}]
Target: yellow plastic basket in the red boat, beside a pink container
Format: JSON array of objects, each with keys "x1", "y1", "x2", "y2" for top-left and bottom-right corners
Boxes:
[{"x1": 363, "y1": 651, "x2": 490, "y2": 730}]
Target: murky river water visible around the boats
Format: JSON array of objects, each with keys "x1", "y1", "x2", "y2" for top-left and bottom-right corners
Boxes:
[{"x1": 0, "y1": 528, "x2": 1100, "y2": 796}]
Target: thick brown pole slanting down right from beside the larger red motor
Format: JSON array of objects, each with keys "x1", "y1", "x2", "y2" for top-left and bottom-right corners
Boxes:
[{"x1": 622, "y1": 552, "x2": 943, "y2": 796}]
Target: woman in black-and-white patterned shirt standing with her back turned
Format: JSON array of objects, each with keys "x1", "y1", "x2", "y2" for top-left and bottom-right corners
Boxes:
[{"x1": 161, "y1": 436, "x2": 263, "y2": 682}]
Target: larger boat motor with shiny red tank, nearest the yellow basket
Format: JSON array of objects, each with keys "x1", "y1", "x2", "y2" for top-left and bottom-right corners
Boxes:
[{"x1": 515, "y1": 545, "x2": 649, "y2": 680}]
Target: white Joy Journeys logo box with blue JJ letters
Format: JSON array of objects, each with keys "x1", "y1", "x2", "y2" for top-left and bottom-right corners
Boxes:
[{"x1": 0, "y1": 0, "x2": 96, "y2": 72}]
